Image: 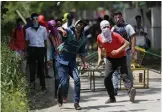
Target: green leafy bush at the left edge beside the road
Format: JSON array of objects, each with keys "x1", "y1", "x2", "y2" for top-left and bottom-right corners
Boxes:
[{"x1": 1, "y1": 43, "x2": 28, "y2": 112}]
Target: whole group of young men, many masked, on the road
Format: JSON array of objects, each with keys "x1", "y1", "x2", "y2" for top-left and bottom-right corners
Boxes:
[{"x1": 10, "y1": 12, "x2": 149, "y2": 110}]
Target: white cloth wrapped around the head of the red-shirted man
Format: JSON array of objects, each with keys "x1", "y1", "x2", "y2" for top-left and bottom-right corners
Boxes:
[{"x1": 100, "y1": 20, "x2": 112, "y2": 43}]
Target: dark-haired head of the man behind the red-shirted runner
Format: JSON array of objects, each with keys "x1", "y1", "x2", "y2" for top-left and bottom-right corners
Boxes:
[{"x1": 114, "y1": 11, "x2": 124, "y2": 25}]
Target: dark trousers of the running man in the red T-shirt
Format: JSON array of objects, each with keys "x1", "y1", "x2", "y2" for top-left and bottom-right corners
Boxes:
[{"x1": 104, "y1": 56, "x2": 133, "y2": 98}]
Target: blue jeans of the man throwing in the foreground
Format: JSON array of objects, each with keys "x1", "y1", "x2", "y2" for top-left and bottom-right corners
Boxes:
[{"x1": 56, "y1": 60, "x2": 80, "y2": 103}]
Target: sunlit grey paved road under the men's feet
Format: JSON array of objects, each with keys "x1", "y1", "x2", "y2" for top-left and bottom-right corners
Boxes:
[{"x1": 31, "y1": 68, "x2": 161, "y2": 112}]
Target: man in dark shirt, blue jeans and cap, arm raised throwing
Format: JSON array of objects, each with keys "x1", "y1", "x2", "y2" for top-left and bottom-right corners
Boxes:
[{"x1": 56, "y1": 20, "x2": 88, "y2": 110}]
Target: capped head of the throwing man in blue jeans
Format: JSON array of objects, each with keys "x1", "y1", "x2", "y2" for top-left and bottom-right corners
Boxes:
[{"x1": 75, "y1": 20, "x2": 88, "y2": 32}]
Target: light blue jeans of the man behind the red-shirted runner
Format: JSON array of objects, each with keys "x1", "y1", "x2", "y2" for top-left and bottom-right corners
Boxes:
[{"x1": 112, "y1": 50, "x2": 133, "y2": 88}]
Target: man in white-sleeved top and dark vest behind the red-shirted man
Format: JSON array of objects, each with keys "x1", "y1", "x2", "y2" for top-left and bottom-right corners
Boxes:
[{"x1": 111, "y1": 11, "x2": 136, "y2": 95}]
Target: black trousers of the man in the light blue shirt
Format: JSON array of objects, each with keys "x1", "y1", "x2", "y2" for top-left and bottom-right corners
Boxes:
[{"x1": 28, "y1": 47, "x2": 45, "y2": 87}]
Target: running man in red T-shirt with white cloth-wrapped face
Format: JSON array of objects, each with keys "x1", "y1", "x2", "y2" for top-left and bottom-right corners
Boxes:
[{"x1": 97, "y1": 20, "x2": 136, "y2": 103}]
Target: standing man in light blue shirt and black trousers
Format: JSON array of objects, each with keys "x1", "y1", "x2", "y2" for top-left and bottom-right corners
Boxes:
[{"x1": 25, "y1": 13, "x2": 47, "y2": 91}]
